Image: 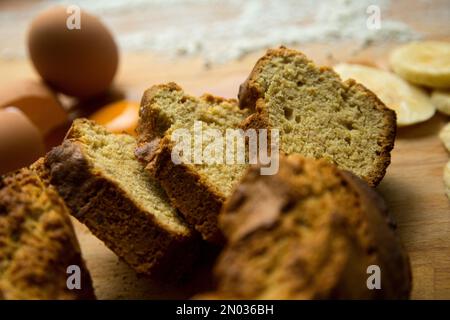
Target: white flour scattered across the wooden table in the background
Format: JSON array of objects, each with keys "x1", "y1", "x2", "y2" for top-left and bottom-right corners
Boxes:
[{"x1": 0, "y1": 0, "x2": 419, "y2": 63}]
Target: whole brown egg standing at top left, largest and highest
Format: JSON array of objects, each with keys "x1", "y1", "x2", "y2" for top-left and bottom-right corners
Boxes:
[{"x1": 28, "y1": 6, "x2": 119, "y2": 98}]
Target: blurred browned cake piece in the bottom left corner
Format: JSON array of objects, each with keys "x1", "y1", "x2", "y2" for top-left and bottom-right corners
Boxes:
[{"x1": 0, "y1": 169, "x2": 95, "y2": 300}]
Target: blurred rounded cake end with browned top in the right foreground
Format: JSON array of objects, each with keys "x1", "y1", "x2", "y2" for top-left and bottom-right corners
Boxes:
[{"x1": 198, "y1": 155, "x2": 411, "y2": 299}]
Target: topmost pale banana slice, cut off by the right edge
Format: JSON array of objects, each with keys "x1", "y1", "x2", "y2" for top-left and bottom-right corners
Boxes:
[{"x1": 390, "y1": 41, "x2": 450, "y2": 88}]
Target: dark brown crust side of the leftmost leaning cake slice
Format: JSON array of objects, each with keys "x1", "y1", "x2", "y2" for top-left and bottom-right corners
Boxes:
[{"x1": 45, "y1": 134, "x2": 198, "y2": 280}]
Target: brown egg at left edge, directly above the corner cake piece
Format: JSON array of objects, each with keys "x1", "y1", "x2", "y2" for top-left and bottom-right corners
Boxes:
[{"x1": 0, "y1": 107, "x2": 44, "y2": 174}]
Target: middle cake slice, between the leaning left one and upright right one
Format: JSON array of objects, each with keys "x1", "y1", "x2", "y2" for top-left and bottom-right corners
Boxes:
[{"x1": 136, "y1": 83, "x2": 249, "y2": 244}]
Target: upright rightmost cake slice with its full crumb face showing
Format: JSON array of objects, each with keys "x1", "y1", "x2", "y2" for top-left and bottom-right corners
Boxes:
[{"x1": 239, "y1": 47, "x2": 396, "y2": 186}]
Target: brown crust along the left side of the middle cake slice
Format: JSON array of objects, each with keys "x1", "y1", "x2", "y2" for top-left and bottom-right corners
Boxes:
[{"x1": 136, "y1": 82, "x2": 241, "y2": 246}]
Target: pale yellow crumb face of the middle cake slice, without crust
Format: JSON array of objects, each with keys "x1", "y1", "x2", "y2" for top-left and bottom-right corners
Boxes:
[{"x1": 138, "y1": 83, "x2": 249, "y2": 197}]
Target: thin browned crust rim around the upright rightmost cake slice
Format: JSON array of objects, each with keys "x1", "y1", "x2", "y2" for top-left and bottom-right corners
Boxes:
[{"x1": 238, "y1": 47, "x2": 397, "y2": 186}]
